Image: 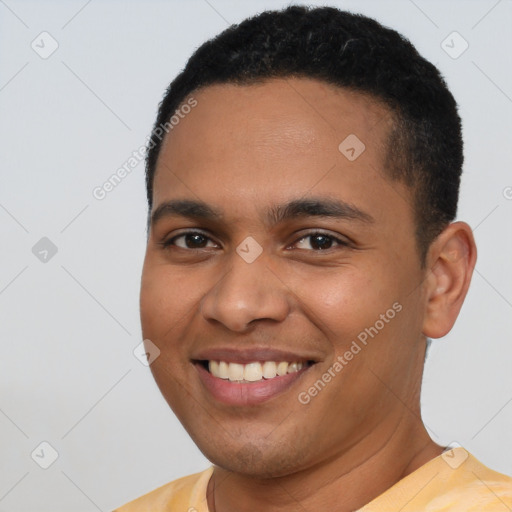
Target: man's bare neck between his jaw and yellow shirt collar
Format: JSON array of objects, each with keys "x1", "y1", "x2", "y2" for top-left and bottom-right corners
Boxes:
[{"x1": 207, "y1": 418, "x2": 443, "y2": 512}]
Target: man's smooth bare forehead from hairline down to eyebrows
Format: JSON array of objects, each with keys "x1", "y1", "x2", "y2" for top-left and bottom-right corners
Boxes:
[{"x1": 153, "y1": 78, "x2": 406, "y2": 226}]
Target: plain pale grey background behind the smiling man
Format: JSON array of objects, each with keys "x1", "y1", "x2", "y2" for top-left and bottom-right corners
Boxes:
[{"x1": 0, "y1": 0, "x2": 512, "y2": 512}]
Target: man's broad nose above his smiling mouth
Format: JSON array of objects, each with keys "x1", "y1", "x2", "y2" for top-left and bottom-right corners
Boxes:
[{"x1": 201, "y1": 252, "x2": 290, "y2": 332}]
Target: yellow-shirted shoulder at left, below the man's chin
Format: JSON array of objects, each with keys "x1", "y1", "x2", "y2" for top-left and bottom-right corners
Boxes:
[{"x1": 114, "y1": 467, "x2": 213, "y2": 512}]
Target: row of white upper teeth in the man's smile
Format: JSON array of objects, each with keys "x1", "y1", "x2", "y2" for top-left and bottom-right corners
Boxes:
[{"x1": 208, "y1": 361, "x2": 304, "y2": 382}]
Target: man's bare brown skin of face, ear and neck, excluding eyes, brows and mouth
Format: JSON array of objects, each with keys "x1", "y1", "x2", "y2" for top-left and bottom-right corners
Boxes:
[{"x1": 140, "y1": 78, "x2": 476, "y2": 512}]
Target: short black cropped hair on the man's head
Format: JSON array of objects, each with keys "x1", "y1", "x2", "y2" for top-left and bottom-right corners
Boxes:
[{"x1": 146, "y1": 5, "x2": 463, "y2": 263}]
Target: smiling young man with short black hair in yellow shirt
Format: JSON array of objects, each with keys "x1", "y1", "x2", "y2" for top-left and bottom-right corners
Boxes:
[{"x1": 114, "y1": 6, "x2": 512, "y2": 512}]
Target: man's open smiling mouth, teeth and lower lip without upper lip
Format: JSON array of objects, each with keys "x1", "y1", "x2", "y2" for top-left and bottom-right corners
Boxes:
[{"x1": 192, "y1": 359, "x2": 315, "y2": 406}]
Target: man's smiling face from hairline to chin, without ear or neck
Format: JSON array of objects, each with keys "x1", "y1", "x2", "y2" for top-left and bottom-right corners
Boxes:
[{"x1": 140, "y1": 78, "x2": 432, "y2": 476}]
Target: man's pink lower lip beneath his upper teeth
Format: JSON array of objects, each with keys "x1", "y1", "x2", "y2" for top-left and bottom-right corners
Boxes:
[{"x1": 195, "y1": 364, "x2": 311, "y2": 405}]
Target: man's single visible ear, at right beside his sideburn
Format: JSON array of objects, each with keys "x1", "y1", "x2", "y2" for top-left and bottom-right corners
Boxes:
[{"x1": 423, "y1": 222, "x2": 476, "y2": 338}]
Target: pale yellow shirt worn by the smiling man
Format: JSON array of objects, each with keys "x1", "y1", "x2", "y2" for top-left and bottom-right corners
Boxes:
[{"x1": 114, "y1": 447, "x2": 512, "y2": 512}]
